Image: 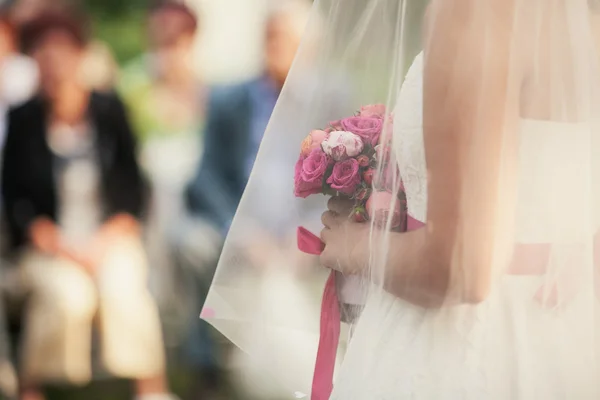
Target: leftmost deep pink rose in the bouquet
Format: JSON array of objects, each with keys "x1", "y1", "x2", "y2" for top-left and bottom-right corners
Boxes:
[{"x1": 294, "y1": 149, "x2": 331, "y2": 198}]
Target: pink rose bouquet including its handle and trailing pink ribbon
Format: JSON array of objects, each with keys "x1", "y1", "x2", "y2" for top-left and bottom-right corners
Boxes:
[{"x1": 294, "y1": 105, "x2": 406, "y2": 399}]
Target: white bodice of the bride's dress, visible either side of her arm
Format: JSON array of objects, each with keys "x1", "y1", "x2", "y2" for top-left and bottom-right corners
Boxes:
[{"x1": 394, "y1": 54, "x2": 599, "y2": 234}]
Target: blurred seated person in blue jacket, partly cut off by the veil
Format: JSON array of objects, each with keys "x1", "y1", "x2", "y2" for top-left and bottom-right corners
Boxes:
[{"x1": 187, "y1": 0, "x2": 310, "y2": 244}]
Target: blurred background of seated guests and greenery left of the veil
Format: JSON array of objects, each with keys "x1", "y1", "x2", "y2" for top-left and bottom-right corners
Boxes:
[{"x1": 0, "y1": 0, "x2": 312, "y2": 400}]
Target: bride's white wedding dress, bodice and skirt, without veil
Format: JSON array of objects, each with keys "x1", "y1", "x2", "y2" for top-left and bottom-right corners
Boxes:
[{"x1": 331, "y1": 55, "x2": 600, "y2": 400}]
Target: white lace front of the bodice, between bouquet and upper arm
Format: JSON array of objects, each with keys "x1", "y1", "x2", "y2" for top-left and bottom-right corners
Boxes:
[{"x1": 394, "y1": 54, "x2": 427, "y2": 221}]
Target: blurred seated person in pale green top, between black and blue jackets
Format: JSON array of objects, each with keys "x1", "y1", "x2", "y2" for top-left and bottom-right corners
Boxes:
[{"x1": 119, "y1": 0, "x2": 205, "y2": 312}]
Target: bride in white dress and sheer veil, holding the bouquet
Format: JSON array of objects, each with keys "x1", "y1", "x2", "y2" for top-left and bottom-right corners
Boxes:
[{"x1": 207, "y1": 0, "x2": 600, "y2": 400}]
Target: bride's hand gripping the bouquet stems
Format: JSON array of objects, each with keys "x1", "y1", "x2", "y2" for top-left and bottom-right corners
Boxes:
[{"x1": 321, "y1": 197, "x2": 370, "y2": 275}]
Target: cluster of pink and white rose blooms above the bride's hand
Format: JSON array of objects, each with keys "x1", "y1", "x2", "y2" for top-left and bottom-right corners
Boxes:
[{"x1": 294, "y1": 104, "x2": 404, "y2": 229}]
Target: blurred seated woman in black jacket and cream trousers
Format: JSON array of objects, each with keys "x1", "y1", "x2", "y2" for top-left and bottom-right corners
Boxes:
[{"x1": 2, "y1": 13, "x2": 172, "y2": 400}]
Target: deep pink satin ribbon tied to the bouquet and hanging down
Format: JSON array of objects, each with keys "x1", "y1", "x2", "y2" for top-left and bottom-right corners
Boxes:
[{"x1": 298, "y1": 216, "x2": 424, "y2": 400}]
